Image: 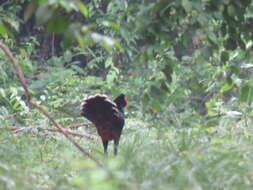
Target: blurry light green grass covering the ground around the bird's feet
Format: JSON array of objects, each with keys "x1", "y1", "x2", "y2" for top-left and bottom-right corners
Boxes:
[{"x1": 0, "y1": 115, "x2": 253, "y2": 190}]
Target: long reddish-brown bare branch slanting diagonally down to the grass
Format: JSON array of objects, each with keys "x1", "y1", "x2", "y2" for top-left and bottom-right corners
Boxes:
[{"x1": 0, "y1": 42, "x2": 103, "y2": 167}]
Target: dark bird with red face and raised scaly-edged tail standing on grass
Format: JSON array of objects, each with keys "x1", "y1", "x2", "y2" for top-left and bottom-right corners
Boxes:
[{"x1": 80, "y1": 94, "x2": 127, "y2": 154}]
